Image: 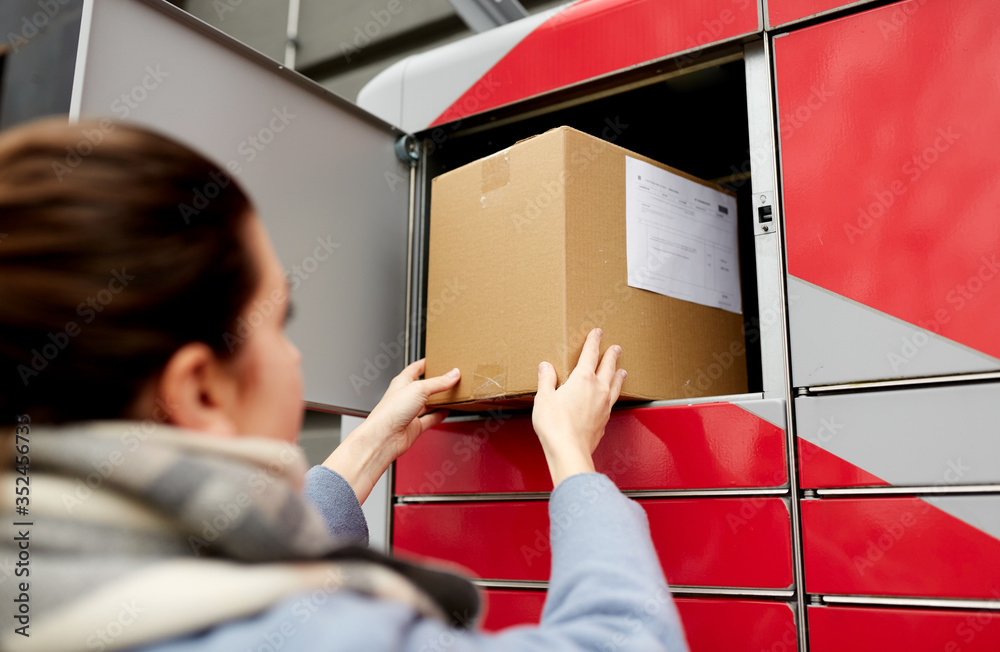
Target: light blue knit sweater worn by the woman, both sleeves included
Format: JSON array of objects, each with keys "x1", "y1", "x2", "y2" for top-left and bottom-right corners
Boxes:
[{"x1": 143, "y1": 467, "x2": 687, "y2": 652}]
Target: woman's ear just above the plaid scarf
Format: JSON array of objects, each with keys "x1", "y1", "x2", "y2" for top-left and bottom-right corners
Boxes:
[{"x1": 156, "y1": 342, "x2": 239, "y2": 436}]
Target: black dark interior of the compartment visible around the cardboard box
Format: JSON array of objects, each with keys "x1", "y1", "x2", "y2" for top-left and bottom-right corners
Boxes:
[{"x1": 425, "y1": 60, "x2": 762, "y2": 392}]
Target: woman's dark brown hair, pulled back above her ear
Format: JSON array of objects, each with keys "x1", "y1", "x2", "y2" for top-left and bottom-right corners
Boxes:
[{"x1": 0, "y1": 119, "x2": 258, "y2": 424}]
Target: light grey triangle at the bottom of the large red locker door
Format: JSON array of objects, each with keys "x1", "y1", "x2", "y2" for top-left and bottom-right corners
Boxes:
[{"x1": 788, "y1": 276, "x2": 1000, "y2": 387}]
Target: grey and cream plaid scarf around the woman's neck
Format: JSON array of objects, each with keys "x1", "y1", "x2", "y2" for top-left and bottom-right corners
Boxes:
[{"x1": 0, "y1": 421, "x2": 479, "y2": 652}]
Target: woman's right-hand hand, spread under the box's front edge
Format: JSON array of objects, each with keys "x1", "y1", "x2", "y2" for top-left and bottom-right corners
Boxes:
[{"x1": 531, "y1": 328, "x2": 626, "y2": 487}]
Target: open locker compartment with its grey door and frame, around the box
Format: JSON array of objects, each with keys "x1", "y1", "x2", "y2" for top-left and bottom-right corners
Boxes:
[{"x1": 71, "y1": 0, "x2": 787, "y2": 415}]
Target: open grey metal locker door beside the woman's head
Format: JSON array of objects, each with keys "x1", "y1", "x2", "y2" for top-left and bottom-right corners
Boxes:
[{"x1": 70, "y1": 0, "x2": 410, "y2": 414}]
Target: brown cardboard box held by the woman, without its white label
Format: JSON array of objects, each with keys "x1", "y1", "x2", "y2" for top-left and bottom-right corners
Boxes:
[{"x1": 426, "y1": 127, "x2": 747, "y2": 410}]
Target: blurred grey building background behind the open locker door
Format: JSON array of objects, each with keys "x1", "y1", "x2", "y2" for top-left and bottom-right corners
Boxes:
[{"x1": 0, "y1": 0, "x2": 566, "y2": 129}]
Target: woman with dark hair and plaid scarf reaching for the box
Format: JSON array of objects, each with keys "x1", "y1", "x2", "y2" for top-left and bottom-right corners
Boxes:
[{"x1": 0, "y1": 120, "x2": 686, "y2": 652}]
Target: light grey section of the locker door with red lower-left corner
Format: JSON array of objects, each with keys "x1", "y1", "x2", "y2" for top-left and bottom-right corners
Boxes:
[{"x1": 795, "y1": 383, "x2": 1000, "y2": 486}]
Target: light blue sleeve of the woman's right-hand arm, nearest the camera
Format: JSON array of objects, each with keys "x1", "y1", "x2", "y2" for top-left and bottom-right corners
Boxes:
[{"x1": 403, "y1": 473, "x2": 688, "y2": 652}]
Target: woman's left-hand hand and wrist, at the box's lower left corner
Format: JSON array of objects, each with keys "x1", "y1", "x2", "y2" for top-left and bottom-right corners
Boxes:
[{"x1": 323, "y1": 359, "x2": 461, "y2": 503}]
